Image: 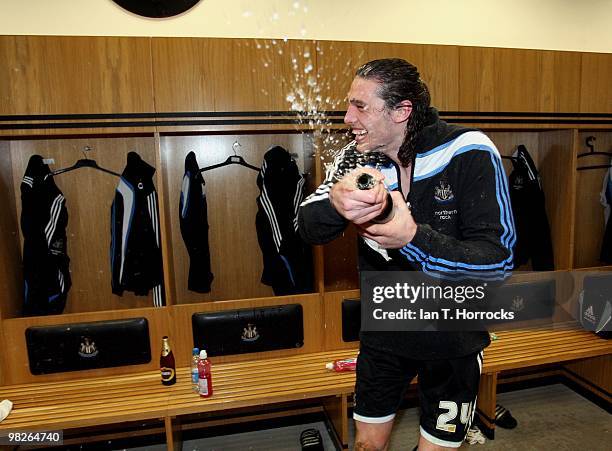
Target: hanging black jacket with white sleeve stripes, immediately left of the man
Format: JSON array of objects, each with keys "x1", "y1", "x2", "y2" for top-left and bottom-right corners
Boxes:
[{"x1": 255, "y1": 146, "x2": 312, "y2": 296}]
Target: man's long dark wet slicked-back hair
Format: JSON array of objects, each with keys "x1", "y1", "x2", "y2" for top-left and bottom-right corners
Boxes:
[{"x1": 355, "y1": 58, "x2": 431, "y2": 166}]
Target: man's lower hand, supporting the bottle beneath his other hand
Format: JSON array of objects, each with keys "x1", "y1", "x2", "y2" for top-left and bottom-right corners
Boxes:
[{"x1": 358, "y1": 191, "x2": 417, "y2": 249}]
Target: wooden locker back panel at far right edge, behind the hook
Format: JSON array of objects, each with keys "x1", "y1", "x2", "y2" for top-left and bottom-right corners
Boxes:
[{"x1": 574, "y1": 132, "x2": 612, "y2": 268}]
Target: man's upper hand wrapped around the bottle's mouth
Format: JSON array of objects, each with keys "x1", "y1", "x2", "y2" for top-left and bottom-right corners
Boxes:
[{"x1": 329, "y1": 168, "x2": 387, "y2": 224}]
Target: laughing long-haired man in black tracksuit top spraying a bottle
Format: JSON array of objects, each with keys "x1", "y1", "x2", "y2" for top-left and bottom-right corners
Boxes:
[{"x1": 299, "y1": 59, "x2": 515, "y2": 451}]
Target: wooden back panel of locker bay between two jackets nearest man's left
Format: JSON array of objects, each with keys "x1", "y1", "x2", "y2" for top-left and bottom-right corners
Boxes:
[{"x1": 161, "y1": 134, "x2": 312, "y2": 304}]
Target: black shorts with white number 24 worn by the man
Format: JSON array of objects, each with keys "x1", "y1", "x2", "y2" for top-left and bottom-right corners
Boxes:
[{"x1": 353, "y1": 345, "x2": 482, "y2": 448}]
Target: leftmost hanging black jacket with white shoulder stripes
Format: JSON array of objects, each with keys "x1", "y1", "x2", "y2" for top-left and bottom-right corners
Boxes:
[{"x1": 21, "y1": 155, "x2": 71, "y2": 316}]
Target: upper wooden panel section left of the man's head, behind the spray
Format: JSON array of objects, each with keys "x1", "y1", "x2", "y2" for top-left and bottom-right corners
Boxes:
[{"x1": 152, "y1": 38, "x2": 315, "y2": 112}]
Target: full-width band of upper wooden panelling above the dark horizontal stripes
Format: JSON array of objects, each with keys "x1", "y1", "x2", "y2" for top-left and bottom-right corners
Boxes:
[{"x1": 0, "y1": 36, "x2": 612, "y2": 114}]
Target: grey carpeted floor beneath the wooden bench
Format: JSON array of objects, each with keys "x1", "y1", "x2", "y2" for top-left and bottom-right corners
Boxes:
[{"x1": 130, "y1": 384, "x2": 612, "y2": 451}]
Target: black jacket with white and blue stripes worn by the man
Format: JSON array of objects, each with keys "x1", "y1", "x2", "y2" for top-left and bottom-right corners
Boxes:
[{"x1": 299, "y1": 108, "x2": 515, "y2": 359}]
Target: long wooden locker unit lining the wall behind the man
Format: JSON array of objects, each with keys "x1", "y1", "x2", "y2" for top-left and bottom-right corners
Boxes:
[{"x1": 0, "y1": 36, "x2": 612, "y2": 442}]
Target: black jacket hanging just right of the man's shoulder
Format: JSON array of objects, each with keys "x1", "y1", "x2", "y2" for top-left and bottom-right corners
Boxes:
[{"x1": 510, "y1": 145, "x2": 555, "y2": 271}]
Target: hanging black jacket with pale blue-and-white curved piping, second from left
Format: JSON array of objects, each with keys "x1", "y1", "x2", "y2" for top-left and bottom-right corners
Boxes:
[{"x1": 111, "y1": 152, "x2": 165, "y2": 307}]
